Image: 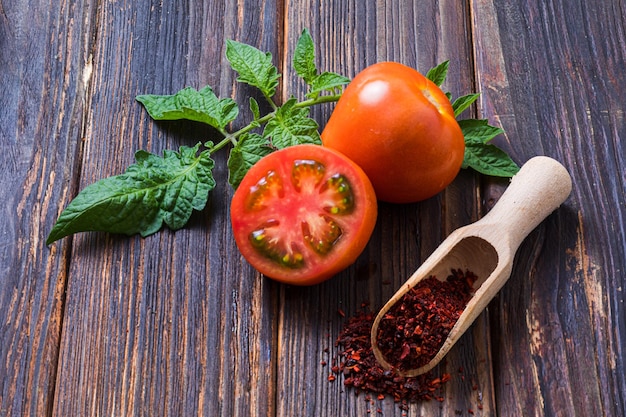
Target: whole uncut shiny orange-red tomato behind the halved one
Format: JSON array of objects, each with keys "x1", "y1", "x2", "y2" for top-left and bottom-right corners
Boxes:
[{"x1": 322, "y1": 62, "x2": 465, "y2": 203}]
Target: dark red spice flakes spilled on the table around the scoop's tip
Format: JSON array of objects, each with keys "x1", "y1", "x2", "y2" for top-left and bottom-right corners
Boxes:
[{"x1": 329, "y1": 312, "x2": 450, "y2": 409}]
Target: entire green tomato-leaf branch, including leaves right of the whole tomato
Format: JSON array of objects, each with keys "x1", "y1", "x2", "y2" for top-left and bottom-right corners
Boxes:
[{"x1": 46, "y1": 29, "x2": 519, "y2": 244}]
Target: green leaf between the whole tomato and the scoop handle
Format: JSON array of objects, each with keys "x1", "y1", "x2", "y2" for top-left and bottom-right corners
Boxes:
[{"x1": 459, "y1": 119, "x2": 519, "y2": 177}]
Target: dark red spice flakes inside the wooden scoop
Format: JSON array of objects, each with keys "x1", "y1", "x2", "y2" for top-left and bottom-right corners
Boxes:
[{"x1": 376, "y1": 269, "x2": 476, "y2": 371}]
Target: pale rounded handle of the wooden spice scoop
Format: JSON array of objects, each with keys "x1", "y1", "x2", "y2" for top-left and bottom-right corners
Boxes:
[{"x1": 478, "y1": 156, "x2": 572, "y2": 248}]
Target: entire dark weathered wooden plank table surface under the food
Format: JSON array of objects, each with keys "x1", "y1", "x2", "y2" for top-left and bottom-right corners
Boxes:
[{"x1": 0, "y1": 0, "x2": 626, "y2": 416}]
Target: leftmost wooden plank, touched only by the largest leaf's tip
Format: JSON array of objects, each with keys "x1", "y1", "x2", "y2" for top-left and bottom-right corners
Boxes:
[{"x1": 0, "y1": 0, "x2": 93, "y2": 416}]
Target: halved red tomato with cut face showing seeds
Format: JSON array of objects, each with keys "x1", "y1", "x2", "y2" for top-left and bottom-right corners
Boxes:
[{"x1": 230, "y1": 145, "x2": 378, "y2": 285}]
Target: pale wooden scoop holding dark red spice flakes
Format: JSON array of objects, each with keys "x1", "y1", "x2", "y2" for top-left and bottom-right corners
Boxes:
[{"x1": 371, "y1": 156, "x2": 572, "y2": 377}]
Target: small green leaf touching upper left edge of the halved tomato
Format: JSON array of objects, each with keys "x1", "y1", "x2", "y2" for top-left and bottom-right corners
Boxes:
[{"x1": 228, "y1": 133, "x2": 274, "y2": 188}]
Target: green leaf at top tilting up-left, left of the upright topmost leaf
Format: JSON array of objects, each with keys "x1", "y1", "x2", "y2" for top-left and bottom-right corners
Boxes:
[{"x1": 226, "y1": 40, "x2": 280, "y2": 98}]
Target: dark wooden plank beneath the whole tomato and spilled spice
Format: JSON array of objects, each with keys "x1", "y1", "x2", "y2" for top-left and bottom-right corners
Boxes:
[{"x1": 277, "y1": 0, "x2": 495, "y2": 416}]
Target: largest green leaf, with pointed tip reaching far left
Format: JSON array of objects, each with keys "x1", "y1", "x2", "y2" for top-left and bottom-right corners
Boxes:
[{"x1": 46, "y1": 144, "x2": 215, "y2": 244}]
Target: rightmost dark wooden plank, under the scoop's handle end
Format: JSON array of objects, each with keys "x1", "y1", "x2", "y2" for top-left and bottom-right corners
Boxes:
[{"x1": 472, "y1": 0, "x2": 626, "y2": 416}]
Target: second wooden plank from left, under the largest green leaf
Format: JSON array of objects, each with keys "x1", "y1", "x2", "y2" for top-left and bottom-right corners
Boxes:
[{"x1": 53, "y1": 1, "x2": 281, "y2": 416}]
